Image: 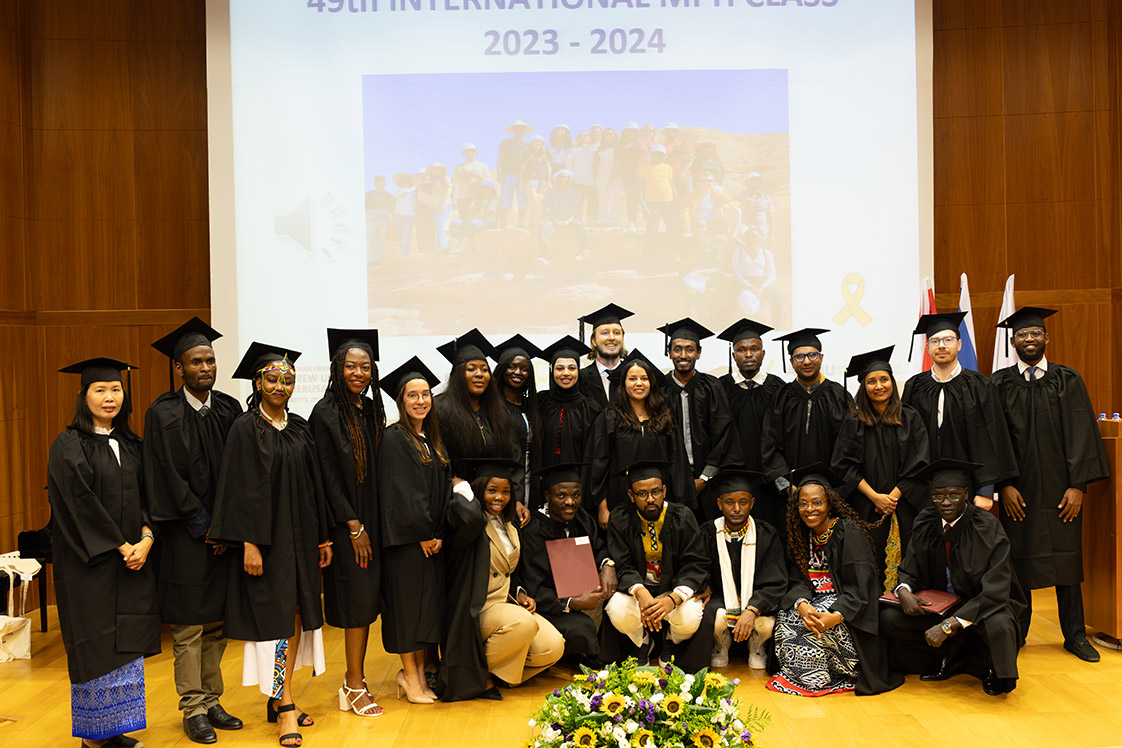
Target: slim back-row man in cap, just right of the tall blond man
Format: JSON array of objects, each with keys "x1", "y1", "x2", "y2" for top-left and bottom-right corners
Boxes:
[{"x1": 659, "y1": 317, "x2": 744, "y2": 518}]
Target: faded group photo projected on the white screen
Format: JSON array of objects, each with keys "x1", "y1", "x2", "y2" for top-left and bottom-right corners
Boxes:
[{"x1": 362, "y1": 70, "x2": 791, "y2": 335}]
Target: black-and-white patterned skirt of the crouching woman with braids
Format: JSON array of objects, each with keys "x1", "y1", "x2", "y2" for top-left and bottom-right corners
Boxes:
[{"x1": 767, "y1": 591, "x2": 858, "y2": 696}]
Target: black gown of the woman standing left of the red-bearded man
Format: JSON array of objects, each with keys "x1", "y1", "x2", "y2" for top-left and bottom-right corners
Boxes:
[{"x1": 833, "y1": 405, "x2": 931, "y2": 565}]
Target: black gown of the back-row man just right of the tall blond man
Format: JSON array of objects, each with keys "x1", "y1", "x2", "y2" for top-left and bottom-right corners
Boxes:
[{"x1": 662, "y1": 371, "x2": 744, "y2": 516}]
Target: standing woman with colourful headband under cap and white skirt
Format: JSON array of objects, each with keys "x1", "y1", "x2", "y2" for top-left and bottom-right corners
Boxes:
[{"x1": 210, "y1": 342, "x2": 334, "y2": 746}]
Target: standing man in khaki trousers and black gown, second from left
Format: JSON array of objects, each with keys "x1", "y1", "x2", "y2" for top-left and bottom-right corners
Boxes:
[{"x1": 144, "y1": 317, "x2": 241, "y2": 744}]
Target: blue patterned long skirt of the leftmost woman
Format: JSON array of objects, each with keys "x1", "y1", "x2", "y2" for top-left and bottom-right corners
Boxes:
[{"x1": 71, "y1": 657, "x2": 145, "y2": 740}]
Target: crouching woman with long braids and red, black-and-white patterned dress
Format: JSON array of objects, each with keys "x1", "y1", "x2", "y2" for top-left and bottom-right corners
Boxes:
[{"x1": 767, "y1": 463, "x2": 903, "y2": 696}]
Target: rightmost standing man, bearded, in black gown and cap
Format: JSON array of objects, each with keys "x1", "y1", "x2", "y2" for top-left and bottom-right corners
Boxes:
[{"x1": 991, "y1": 306, "x2": 1110, "y2": 662}]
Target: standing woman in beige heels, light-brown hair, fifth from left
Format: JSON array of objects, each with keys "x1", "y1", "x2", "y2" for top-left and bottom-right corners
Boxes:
[{"x1": 378, "y1": 357, "x2": 452, "y2": 704}]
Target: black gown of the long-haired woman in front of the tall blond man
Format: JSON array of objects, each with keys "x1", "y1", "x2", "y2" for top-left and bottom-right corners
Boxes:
[{"x1": 581, "y1": 408, "x2": 682, "y2": 516}]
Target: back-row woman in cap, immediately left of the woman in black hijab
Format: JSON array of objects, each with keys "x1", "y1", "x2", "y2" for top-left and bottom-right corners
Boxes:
[{"x1": 495, "y1": 335, "x2": 542, "y2": 507}]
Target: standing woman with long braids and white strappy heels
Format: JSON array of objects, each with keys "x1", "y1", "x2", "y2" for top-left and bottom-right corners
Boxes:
[{"x1": 309, "y1": 329, "x2": 386, "y2": 717}]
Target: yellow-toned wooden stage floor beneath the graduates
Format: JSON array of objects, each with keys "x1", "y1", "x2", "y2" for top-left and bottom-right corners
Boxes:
[{"x1": 0, "y1": 590, "x2": 1122, "y2": 748}]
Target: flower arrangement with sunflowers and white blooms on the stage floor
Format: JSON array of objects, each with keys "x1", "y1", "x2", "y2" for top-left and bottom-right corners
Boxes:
[{"x1": 527, "y1": 657, "x2": 771, "y2": 748}]
